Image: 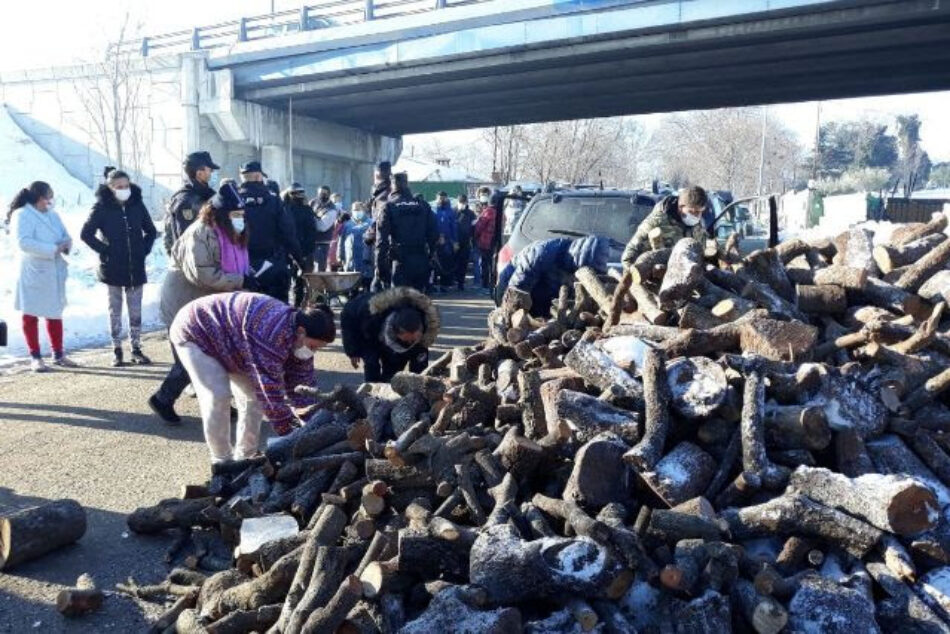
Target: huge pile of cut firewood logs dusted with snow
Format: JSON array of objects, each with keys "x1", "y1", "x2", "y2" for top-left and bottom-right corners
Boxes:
[{"x1": 124, "y1": 216, "x2": 950, "y2": 634}]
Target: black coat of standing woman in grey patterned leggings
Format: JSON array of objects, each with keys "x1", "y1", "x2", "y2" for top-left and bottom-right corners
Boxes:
[{"x1": 80, "y1": 180, "x2": 158, "y2": 286}]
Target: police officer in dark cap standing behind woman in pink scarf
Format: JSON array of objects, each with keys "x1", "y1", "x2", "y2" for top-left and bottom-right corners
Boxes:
[{"x1": 238, "y1": 161, "x2": 311, "y2": 302}]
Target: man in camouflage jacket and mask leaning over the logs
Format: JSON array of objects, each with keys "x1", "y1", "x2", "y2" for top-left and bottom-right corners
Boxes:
[{"x1": 621, "y1": 186, "x2": 709, "y2": 270}]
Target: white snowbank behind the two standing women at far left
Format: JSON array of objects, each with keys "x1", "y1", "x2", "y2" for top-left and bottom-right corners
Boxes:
[{"x1": 0, "y1": 107, "x2": 167, "y2": 368}]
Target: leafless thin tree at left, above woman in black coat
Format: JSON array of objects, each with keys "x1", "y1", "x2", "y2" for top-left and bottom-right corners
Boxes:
[{"x1": 73, "y1": 13, "x2": 149, "y2": 172}]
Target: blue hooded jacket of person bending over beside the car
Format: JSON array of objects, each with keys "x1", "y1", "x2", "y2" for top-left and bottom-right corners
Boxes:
[{"x1": 498, "y1": 236, "x2": 610, "y2": 317}]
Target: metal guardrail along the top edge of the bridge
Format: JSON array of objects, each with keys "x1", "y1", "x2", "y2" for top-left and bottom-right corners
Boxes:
[{"x1": 113, "y1": 0, "x2": 488, "y2": 57}]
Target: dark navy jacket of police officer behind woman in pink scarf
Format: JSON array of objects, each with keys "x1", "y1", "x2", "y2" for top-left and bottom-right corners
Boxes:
[{"x1": 238, "y1": 182, "x2": 303, "y2": 268}]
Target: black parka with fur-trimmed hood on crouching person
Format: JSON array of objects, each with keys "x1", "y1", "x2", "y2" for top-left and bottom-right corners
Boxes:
[{"x1": 340, "y1": 286, "x2": 441, "y2": 358}]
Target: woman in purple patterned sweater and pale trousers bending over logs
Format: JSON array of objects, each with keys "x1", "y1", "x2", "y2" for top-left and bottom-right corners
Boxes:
[{"x1": 169, "y1": 292, "x2": 336, "y2": 462}]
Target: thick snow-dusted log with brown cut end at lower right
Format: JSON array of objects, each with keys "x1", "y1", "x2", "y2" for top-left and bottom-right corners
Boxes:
[{"x1": 789, "y1": 467, "x2": 938, "y2": 535}]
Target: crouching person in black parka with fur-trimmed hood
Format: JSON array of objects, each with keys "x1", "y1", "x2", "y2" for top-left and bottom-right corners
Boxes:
[{"x1": 340, "y1": 286, "x2": 440, "y2": 383}]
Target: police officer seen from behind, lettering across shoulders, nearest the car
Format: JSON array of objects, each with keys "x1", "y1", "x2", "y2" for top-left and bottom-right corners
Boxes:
[{"x1": 376, "y1": 172, "x2": 439, "y2": 293}]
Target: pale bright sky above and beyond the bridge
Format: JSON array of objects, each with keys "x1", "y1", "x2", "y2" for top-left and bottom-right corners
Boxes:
[{"x1": 7, "y1": 0, "x2": 950, "y2": 161}]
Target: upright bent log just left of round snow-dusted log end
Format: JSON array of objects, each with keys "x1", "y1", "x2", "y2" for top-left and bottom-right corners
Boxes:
[{"x1": 624, "y1": 348, "x2": 670, "y2": 473}]
